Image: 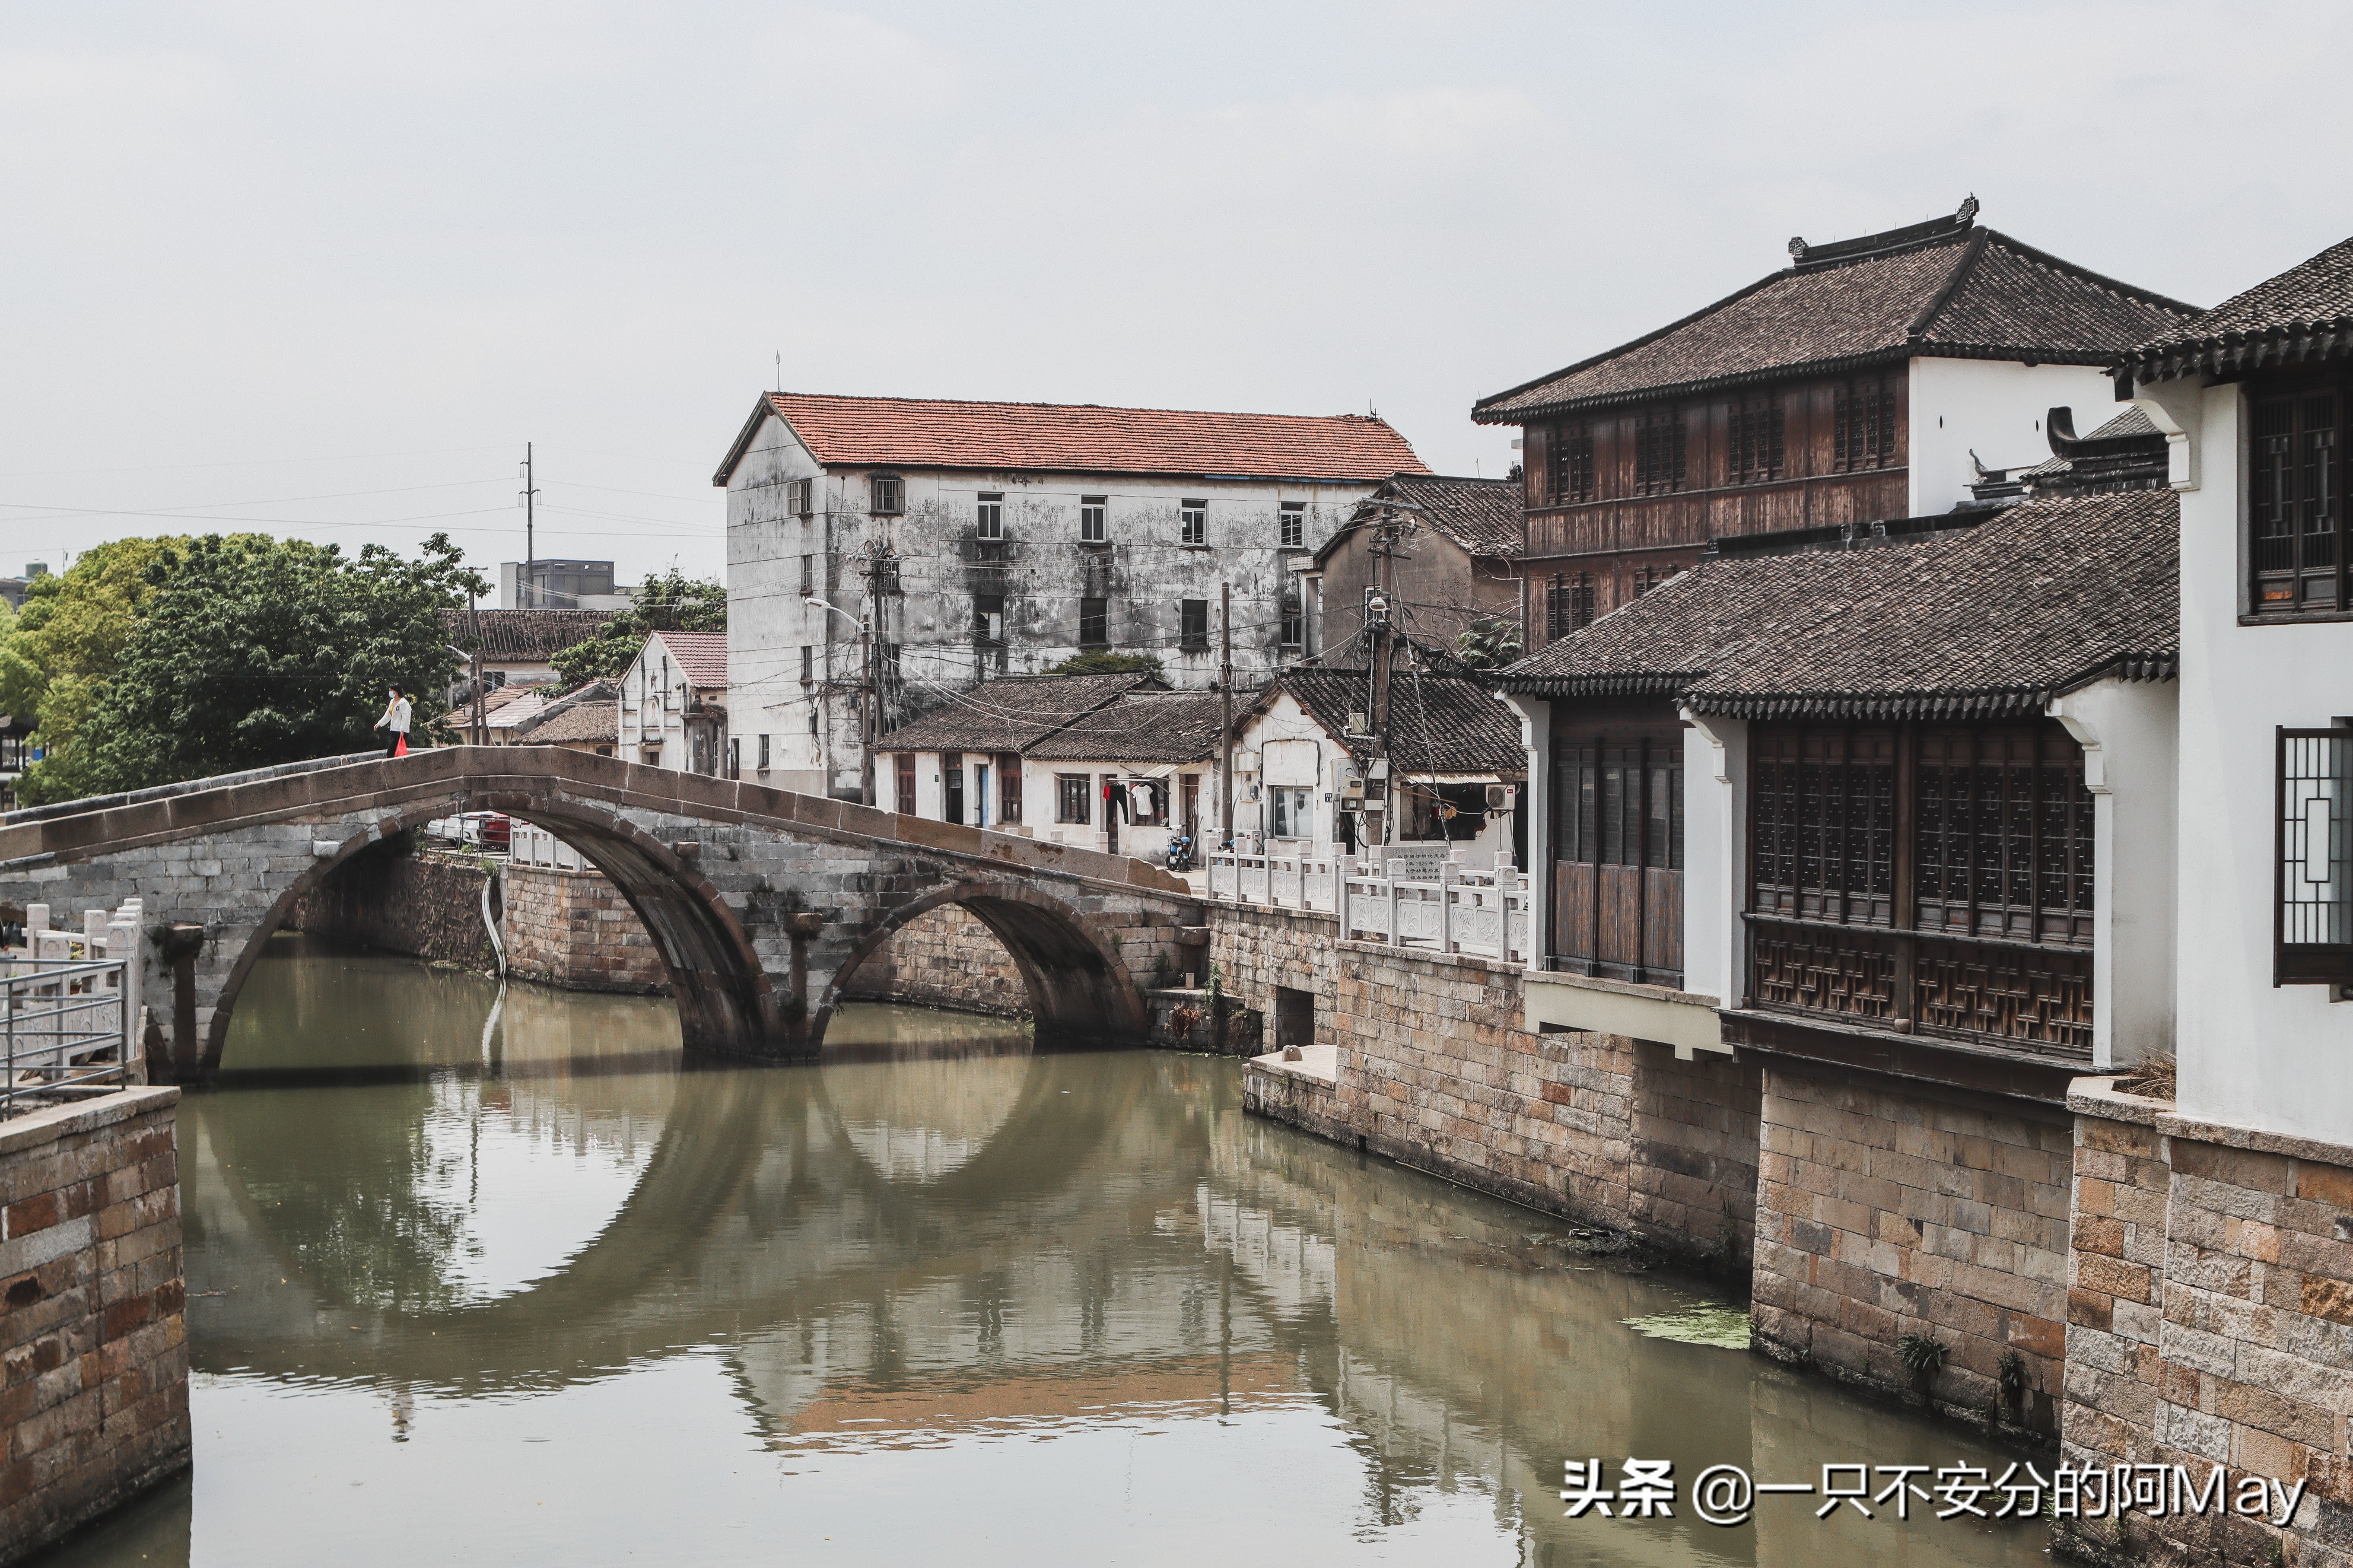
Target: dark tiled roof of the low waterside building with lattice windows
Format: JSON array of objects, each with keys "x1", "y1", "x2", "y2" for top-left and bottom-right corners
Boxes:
[{"x1": 1503, "y1": 489, "x2": 2181, "y2": 718}]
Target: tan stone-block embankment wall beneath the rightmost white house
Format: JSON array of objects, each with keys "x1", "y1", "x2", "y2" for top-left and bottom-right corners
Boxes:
[{"x1": 2061, "y1": 1079, "x2": 2353, "y2": 1568}]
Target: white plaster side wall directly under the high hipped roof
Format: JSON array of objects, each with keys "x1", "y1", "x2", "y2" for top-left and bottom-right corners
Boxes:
[{"x1": 1908, "y1": 355, "x2": 2117, "y2": 518}]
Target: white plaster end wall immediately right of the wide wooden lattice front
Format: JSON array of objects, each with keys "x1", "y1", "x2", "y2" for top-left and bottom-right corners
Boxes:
[{"x1": 2049, "y1": 680, "x2": 2181, "y2": 1067}]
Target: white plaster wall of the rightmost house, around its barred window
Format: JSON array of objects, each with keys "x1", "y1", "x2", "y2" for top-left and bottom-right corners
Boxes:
[{"x1": 2139, "y1": 384, "x2": 2353, "y2": 1142}]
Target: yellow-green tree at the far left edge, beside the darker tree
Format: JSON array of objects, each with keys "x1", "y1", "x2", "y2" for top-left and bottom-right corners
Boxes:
[{"x1": 0, "y1": 539, "x2": 188, "y2": 803}]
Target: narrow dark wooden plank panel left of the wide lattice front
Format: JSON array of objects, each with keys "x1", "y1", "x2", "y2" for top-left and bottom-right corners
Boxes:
[{"x1": 1548, "y1": 702, "x2": 1683, "y2": 987}]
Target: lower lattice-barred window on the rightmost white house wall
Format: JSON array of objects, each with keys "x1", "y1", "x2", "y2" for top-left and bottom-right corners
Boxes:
[{"x1": 2271, "y1": 727, "x2": 2353, "y2": 987}]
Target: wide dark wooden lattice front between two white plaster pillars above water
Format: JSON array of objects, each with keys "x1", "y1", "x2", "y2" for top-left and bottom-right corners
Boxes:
[{"x1": 1748, "y1": 720, "x2": 2094, "y2": 1057}]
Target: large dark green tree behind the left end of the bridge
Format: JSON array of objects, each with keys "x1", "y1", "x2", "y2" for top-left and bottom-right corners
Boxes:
[{"x1": 49, "y1": 535, "x2": 487, "y2": 798}]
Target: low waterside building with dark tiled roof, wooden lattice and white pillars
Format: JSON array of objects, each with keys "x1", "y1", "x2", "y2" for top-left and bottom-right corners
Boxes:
[{"x1": 1503, "y1": 489, "x2": 2179, "y2": 1067}]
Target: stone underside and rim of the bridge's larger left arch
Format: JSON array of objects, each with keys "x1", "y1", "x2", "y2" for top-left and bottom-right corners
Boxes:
[{"x1": 200, "y1": 793, "x2": 781, "y2": 1074}]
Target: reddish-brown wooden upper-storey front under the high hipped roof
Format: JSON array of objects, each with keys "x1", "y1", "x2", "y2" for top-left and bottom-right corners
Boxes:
[{"x1": 1522, "y1": 360, "x2": 1910, "y2": 647}]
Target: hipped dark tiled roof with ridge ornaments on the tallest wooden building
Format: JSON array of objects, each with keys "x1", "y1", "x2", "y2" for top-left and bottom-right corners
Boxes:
[{"x1": 1471, "y1": 219, "x2": 2195, "y2": 424}]
